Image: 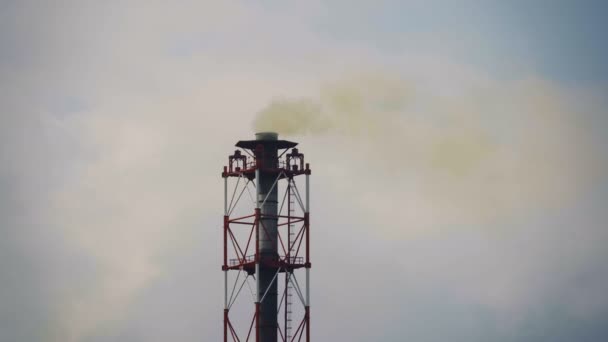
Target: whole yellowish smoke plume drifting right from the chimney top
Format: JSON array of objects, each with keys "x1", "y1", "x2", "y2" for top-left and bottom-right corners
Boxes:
[{"x1": 254, "y1": 74, "x2": 604, "y2": 230}]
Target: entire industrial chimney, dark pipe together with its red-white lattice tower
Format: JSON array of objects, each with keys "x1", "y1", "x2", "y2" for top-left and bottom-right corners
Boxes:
[{"x1": 222, "y1": 132, "x2": 311, "y2": 342}]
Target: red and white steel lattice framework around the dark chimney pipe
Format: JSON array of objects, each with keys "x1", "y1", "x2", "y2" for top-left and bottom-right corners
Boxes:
[{"x1": 222, "y1": 134, "x2": 311, "y2": 342}]
